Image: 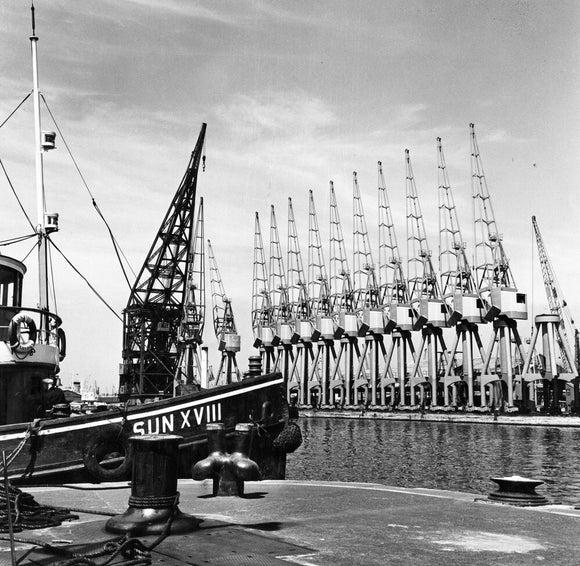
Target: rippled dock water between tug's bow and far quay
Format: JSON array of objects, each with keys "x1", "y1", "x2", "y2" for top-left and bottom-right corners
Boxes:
[{"x1": 287, "y1": 418, "x2": 580, "y2": 505}]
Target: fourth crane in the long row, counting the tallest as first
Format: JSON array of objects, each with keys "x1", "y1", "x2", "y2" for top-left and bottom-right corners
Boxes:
[{"x1": 378, "y1": 161, "x2": 415, "y2": 406}]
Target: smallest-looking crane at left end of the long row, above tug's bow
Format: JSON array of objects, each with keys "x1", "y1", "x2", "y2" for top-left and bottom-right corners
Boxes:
[{"x1": 252, "y1": 212, "x2": 280, "y2": 373}]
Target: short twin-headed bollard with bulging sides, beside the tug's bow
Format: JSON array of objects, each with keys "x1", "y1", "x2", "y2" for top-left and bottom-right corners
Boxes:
[{"x1": 191, "y1": 423, "x2": 260, "y2": 496}]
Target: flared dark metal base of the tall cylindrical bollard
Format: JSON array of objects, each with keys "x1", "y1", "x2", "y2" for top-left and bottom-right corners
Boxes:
[{"x1": 105, "y1": 507, "x2": 201, "y2": 535}]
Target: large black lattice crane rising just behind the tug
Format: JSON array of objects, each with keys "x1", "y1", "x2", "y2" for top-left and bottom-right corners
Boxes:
[{"x1": 119, "y1": 124, "x2": 206, "y2": 398}]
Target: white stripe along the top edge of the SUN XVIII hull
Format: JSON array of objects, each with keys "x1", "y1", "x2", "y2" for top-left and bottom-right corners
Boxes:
[{"x1": 0, "y1": 377, "x2": 284, "y2": 442}]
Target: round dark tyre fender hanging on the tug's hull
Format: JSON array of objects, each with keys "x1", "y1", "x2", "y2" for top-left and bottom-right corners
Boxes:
[{"x1": 83, "y1": 425, "x2": 133, "y2": 481}]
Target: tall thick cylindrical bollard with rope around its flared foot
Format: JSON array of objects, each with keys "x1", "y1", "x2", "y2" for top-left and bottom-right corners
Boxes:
[{"x1": 105, "y1": 434, "x2": 200, "y2": 535}]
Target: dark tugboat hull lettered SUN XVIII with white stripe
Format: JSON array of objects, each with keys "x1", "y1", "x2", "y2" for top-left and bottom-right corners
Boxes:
[{"x1": 0, "y1": 374, "x2": 288, "y2": 484}]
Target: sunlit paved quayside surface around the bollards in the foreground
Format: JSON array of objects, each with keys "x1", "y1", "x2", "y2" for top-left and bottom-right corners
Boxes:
[{"x1": 0, "y1": 480, "x2": 580, "y2": 566}]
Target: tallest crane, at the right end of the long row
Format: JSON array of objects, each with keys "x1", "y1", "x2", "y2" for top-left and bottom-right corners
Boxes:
[{"x1": 469, "y1": 124, "x2": 528, "y2": 409}]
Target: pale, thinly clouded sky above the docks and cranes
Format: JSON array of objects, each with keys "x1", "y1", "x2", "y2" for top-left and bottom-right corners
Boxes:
[{"x1": 0, "y1": 0, "x2": 580, "y2": 390}]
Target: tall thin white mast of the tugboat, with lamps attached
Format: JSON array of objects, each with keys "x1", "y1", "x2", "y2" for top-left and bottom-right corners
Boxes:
[{"x1": 30, "y1": 4, "x2": 48, "y2": 330}]
